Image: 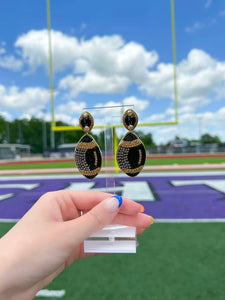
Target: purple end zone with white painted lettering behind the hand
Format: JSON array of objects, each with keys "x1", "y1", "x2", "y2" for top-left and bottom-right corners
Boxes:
[{"x1": 0, "y1": 173, "x2": 225, "y2": 219}]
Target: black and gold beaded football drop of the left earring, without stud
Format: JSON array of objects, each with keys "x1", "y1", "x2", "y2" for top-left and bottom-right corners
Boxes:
[{"x1": 75, "y1": 134, "x2": 102, "y2": 179}]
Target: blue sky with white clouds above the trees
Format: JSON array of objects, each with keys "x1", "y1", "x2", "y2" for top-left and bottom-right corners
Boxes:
[{"x1": 0, "y1": 0, "x2": 225, "y2": 143}]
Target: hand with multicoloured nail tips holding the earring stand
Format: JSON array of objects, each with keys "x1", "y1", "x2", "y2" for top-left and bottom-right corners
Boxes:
[{"x1": 0, "y1": 191, "x2": 154, "y2": 300}]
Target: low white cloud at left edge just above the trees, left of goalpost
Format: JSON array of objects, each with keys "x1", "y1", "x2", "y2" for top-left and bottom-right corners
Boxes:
[{"x1": 0, "y1": 85, "x2": 50, "y2": 116}]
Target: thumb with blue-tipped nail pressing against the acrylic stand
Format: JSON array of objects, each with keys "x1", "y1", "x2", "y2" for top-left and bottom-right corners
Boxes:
[{"x1": 65, "y1": 195, "x2": 123, "y2": 246}]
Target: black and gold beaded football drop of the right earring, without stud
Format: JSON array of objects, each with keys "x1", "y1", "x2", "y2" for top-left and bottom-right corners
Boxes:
[{"x1": 116, "y1": 131, "x2": 146, "y2": 177}]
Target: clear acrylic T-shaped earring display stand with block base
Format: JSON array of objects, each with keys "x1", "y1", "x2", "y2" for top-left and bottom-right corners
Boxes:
[{"x1": 84, "y1": 105, "x2": 136, "y2": 253}]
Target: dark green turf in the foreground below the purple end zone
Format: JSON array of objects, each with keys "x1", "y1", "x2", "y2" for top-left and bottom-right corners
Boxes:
[{"x1": 0, "y1": 223, "x2": 225, "y2": 300}]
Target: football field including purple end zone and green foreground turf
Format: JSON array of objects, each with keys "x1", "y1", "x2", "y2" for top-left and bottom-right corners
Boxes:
[{"x1": 0, "y1": 171, "x2": 225, "y2": 300}]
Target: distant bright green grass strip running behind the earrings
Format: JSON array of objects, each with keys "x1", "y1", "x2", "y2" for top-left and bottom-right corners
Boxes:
[{"x1": 0, "y1": 157, "x2": 225, "y2": 170}]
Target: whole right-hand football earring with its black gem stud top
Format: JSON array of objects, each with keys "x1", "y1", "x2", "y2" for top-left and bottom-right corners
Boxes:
[{"x1": 116, "y1": 109, "x2": 146, "y2": 177}]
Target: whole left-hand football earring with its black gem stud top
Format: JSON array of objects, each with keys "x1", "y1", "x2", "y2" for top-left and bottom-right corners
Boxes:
[{"x1": 75, "y1": 111, "x2": 102, "y2": 179}]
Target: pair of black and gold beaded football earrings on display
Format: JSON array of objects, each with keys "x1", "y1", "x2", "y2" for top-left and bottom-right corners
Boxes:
[{"x1": 75, "y1": 109, "x2": 146, "y2": 180}]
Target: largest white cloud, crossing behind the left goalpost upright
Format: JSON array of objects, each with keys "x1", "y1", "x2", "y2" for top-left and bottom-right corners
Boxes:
[{"x1": 15, "y1": 30, "x2": 158, "y2": 96}]
